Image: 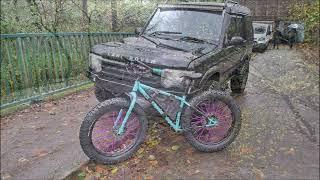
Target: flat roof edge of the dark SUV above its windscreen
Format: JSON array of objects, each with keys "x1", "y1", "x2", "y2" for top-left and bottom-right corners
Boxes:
[{"x1": 158, "y1": 2, "x2": 251, "y2": 16}]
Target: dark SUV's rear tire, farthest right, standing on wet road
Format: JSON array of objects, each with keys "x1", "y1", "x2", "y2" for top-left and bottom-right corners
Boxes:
[{"x1": 230, "y1": 60, "x2": 250, "y2": 94}]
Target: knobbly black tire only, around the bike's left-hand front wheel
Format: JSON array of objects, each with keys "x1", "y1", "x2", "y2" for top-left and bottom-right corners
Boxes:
[{"x1": 79, "y1": 98, "x2": 148, "y2": 164}]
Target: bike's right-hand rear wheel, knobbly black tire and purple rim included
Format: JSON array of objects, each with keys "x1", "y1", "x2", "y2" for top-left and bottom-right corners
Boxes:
[{"x1": 182, "y1": 91, "x2": 241, "y2": 152}]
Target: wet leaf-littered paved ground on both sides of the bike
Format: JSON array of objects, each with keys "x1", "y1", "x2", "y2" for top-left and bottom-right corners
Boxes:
[{"x1": 1, "y1": 49, "x2": 319, "y2": 179}]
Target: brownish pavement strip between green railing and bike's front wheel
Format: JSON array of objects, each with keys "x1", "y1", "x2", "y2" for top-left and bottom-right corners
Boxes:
[{"x1": 1, "y1": 91, "x2": 97, "y2": 180}]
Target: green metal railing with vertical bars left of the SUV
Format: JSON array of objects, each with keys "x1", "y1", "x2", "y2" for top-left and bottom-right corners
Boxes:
[{"x1": 0, "y1": 33, "x2": 134, "y2": 109}]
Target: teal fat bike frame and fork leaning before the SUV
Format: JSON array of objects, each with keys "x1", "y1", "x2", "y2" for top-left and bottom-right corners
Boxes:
[{"x1": 115, "y1": 80, "x2": 190, "y2": 135}]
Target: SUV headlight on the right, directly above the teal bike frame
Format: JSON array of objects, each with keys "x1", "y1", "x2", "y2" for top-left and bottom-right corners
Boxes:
[{"x1": 161, "y1": 69, "x2": 201, "y2": 89}]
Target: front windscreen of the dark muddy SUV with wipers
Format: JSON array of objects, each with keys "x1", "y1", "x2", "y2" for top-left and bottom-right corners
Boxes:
[{"x1": 144, "y1": 8, "x2": 223, "y2": 41}]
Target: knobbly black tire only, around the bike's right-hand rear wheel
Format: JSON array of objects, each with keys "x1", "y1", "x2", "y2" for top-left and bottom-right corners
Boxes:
[{"x1": 182, "y1": 91, "x2": 241, "y2": 152}]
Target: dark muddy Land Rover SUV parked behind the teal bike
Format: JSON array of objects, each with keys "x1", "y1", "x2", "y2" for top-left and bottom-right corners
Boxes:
[{"x1": 88, "y1": 3, "x2": 253, "y2": 101}]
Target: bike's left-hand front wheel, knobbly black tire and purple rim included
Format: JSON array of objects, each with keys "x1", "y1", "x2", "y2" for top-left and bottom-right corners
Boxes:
[{"x1": 79, "y1": 98, "x2": 147, "y2": 164}]
